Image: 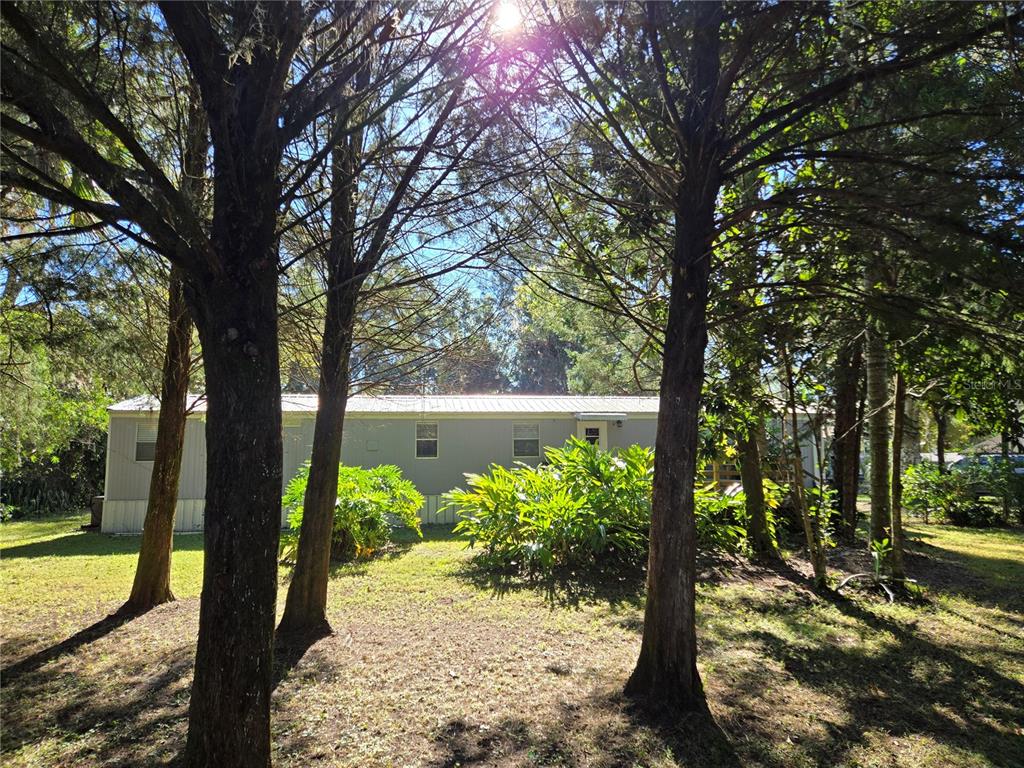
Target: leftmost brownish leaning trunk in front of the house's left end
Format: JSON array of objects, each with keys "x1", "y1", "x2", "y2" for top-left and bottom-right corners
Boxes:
[{"x1": 121, "y1": 267, "x2": 191, "y2": 613}]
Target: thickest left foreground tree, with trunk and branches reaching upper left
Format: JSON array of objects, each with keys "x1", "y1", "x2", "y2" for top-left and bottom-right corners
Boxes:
[{"x1": 2, "y1": 3, "x2": 364, "y2": 766}]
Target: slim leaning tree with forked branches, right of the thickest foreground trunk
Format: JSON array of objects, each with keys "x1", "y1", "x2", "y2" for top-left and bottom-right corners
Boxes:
[{"x1": 279, "y1": 6, "x2": 495, "y2": 634}]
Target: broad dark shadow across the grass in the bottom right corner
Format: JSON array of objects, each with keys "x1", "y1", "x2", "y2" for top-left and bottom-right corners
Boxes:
[{"x1": 730, "y1": 567, "x2": 1024, "y2": 768}]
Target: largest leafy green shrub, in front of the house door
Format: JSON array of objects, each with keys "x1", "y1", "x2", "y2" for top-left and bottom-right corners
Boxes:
[{"x1": 444, "y1": 438, "x2": 781, "y2": 572}]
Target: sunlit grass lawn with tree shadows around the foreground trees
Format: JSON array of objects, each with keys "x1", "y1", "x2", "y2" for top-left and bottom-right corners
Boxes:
[{"x1": 0, "y1": 518, "x2": 1024, "y2": 768}]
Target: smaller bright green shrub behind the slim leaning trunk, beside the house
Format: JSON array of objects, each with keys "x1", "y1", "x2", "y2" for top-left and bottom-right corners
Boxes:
[{"x1": 282, "y1": 463, "x2": 423, "y2": 560}]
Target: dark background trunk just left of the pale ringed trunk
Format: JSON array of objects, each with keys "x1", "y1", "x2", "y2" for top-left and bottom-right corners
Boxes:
[{"x1": 833, "y1": 337, "x2": 863, "y2": 544}]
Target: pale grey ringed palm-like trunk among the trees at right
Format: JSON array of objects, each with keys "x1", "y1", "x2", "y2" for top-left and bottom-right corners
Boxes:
[{"x1": 866, "y1": 309, "x2": 890, "y2": 545}]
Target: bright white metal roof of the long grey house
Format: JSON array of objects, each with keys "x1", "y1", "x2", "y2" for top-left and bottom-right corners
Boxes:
[{"x1": 108, "y1": 392, "x2": 657, "y2": 416}]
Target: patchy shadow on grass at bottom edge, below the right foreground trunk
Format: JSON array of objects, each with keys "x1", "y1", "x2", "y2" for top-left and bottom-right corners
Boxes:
[{"x1": 428, "y1": 692, "x2": 741, "y2": 768}]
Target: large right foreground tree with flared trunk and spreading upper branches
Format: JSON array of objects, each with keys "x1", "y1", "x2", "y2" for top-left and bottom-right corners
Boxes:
[{"x1": 516, "y1": 3, "x2": 1017, "y2": 710}]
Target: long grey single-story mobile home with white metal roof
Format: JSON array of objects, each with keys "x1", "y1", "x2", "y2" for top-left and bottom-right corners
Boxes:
[{"x1": 102, "y1": 394, "x2": 657, "y2": 534}]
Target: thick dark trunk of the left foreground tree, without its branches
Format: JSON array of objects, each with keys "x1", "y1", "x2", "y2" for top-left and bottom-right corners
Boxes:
[{"x1": 180, "y1": 66, "x2": 294, "y2": 768}]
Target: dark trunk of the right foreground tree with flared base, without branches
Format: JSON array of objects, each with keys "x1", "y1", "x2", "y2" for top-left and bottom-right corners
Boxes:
[{"x1": 626, "y1": 3, "x2": 722, "y2": 712}]
